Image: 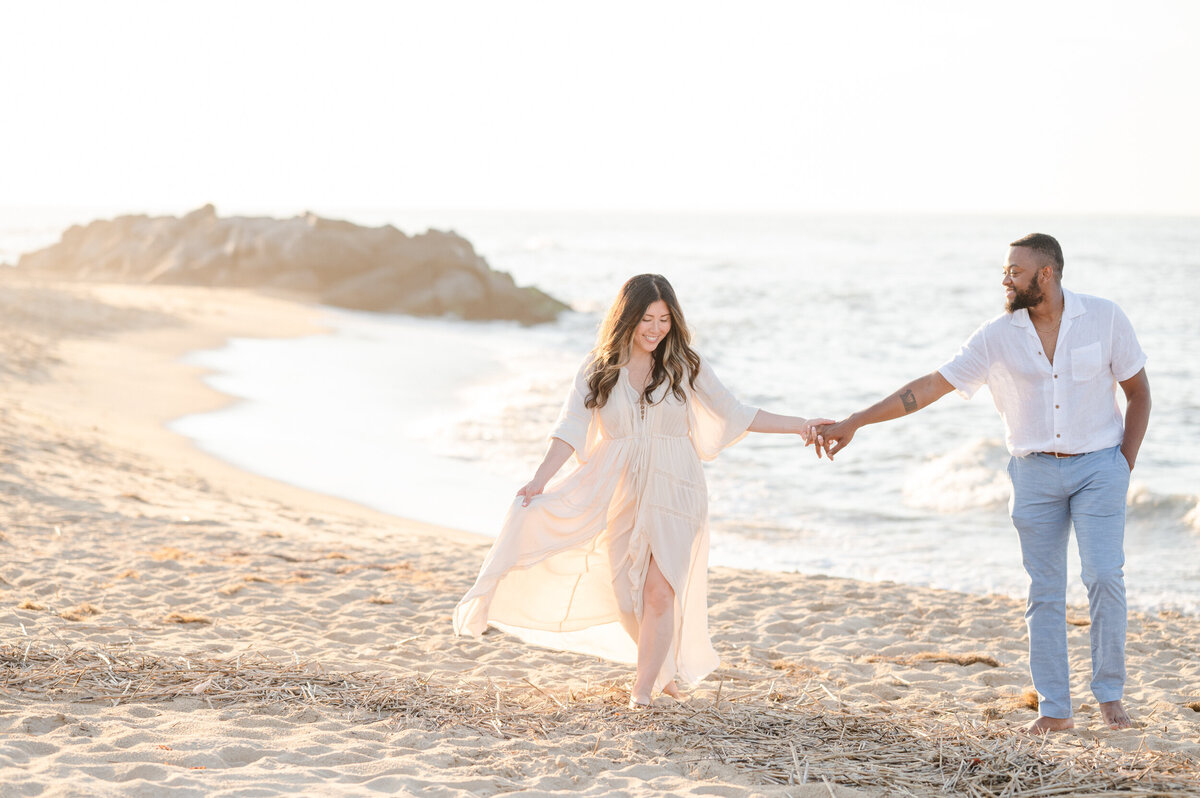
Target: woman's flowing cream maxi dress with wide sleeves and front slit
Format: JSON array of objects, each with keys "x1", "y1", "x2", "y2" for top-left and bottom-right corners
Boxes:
[{"x1": 454, "y1": 359, "x2": 757, "y2": 689}]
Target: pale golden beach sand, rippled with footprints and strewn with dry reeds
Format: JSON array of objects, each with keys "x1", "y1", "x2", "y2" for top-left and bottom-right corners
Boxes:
[{"x1": 0, "y1": 270, "x2": 1200, "y2": 796}]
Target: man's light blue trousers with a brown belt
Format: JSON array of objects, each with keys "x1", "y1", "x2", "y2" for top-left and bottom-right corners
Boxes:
[{"x1": 1008, "y1": 446, "x2": 1129, "y2": 718}]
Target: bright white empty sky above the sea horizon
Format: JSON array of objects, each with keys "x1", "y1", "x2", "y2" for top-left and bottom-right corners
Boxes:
[{"x1": 0, "y1": 0, "x2": 1200, "y2": 215}]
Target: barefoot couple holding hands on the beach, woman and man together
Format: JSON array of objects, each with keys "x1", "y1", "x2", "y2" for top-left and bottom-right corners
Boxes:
[{"x1": 454, "y1": 233, "x2": 1151, "y2": 733}]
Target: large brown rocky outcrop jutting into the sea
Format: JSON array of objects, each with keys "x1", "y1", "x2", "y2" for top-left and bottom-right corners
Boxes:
[{"x1": 17, "y1": 205, "x2": 566, "y2": 324}]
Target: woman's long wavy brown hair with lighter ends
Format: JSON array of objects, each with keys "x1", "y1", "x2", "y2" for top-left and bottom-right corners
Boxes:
[{"x1": 584, "y1": 275, "x2": 700, "y2": 408}]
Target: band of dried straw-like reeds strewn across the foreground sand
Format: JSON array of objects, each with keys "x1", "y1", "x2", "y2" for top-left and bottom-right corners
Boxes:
[{"x1": 0, "y1": 643, "x2": 1200, "y2": 798}]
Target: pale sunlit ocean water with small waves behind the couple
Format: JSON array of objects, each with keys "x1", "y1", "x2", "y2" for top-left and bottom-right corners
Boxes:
[{"x1": 0, "y1": 210, "x2": 1200, "y2": 612}]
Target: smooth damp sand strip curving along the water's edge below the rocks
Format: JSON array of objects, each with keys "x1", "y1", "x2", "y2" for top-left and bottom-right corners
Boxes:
[{"x1": 4, "y1": 271, "x2": 487, "y2": 542}]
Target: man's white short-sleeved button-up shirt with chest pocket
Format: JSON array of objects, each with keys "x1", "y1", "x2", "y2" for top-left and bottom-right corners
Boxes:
[{"x1": 937, "y1": 289, "x2": 1146, "y2": 457}]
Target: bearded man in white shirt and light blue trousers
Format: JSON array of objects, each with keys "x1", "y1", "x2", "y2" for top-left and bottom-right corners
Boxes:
[{"x1": 817, "y1": 233, "x2": 1150, "y2": 734}]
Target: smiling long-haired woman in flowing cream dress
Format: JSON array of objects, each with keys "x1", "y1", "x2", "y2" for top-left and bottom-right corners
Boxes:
[{"x1": 454, "y1": 275, "x2": 829, "y2": 708}]
